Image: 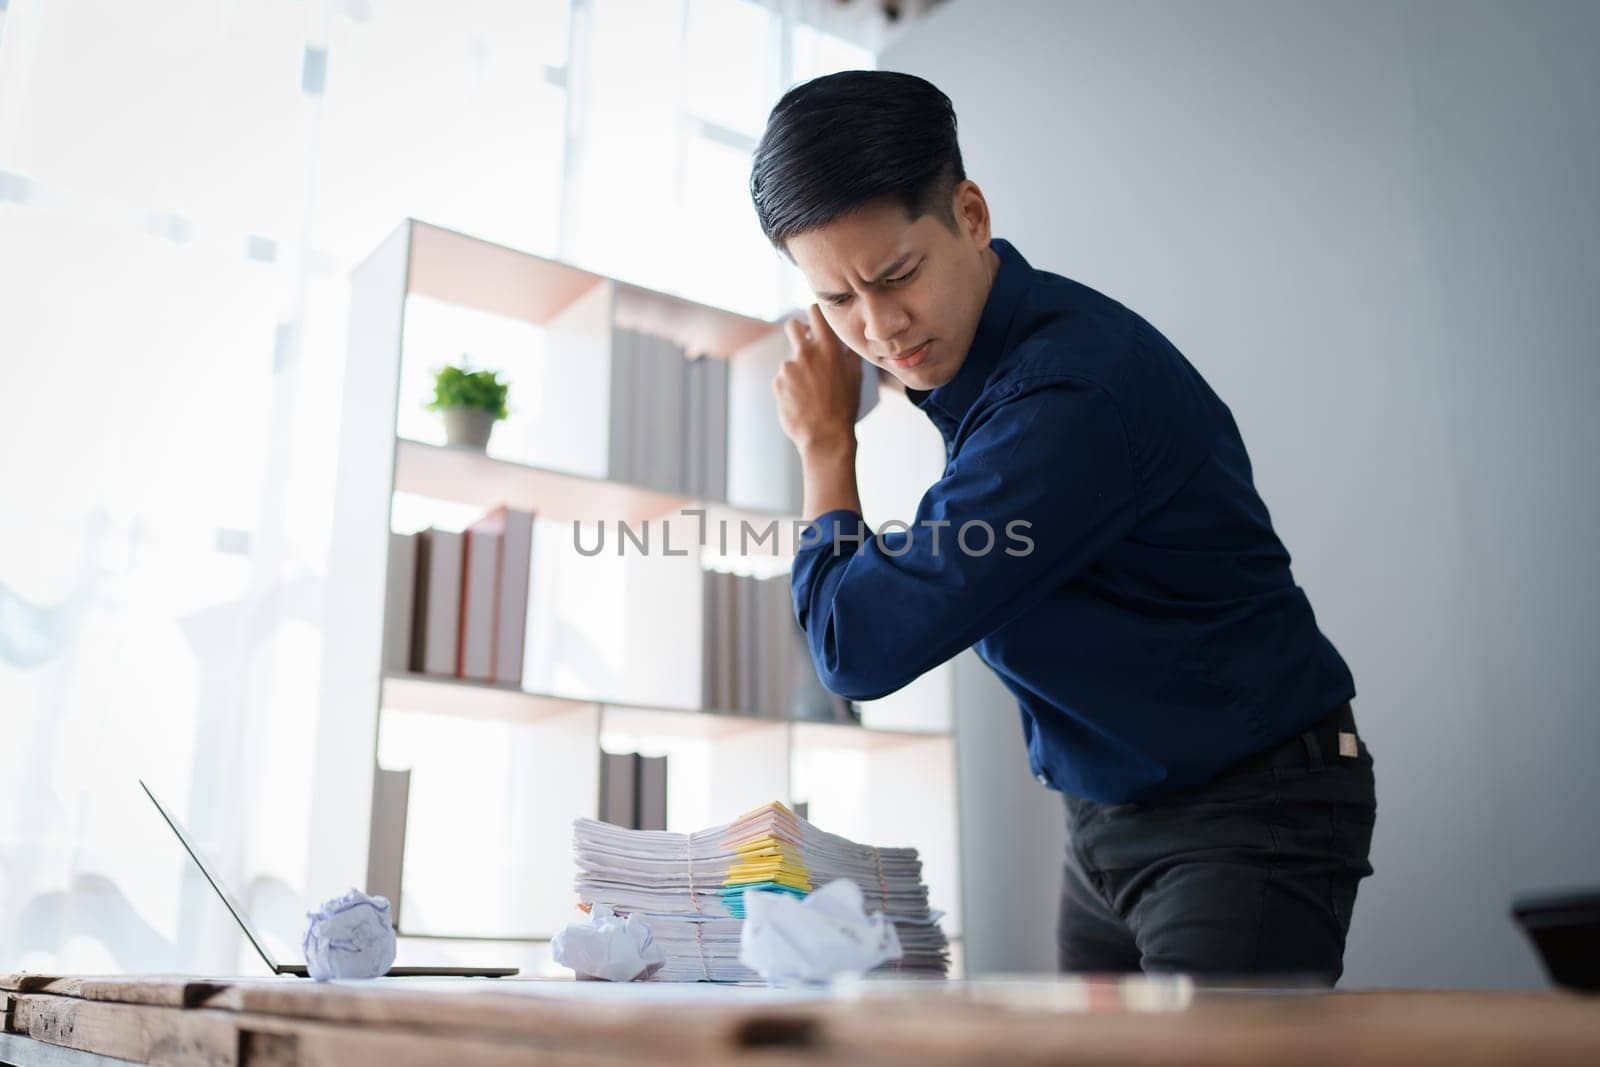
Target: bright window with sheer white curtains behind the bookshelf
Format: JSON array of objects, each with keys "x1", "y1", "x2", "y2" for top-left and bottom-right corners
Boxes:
[{"x1": 0, "y1": 0, "x2": 870, "y2": 973}]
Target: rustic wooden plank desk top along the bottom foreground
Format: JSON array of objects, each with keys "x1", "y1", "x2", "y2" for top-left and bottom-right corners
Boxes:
[{"x1": 0, "y1": 974, "x2": 1600, "y2": 1067}]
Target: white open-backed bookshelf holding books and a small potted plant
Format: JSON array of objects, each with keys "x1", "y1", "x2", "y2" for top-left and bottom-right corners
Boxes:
[{"x1": 307, "y1": 221, "x2": 962, "y2": 961}]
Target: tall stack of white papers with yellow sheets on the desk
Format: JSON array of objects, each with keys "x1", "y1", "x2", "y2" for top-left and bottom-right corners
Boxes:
[{"x1": 573, "y1": 803, "x2": 949, "y2": 982}]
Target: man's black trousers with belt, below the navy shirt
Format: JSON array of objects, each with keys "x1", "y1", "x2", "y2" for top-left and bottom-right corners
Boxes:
[{"x1": 1056, "y1": 704, "x2": 1376, "y2": 985}]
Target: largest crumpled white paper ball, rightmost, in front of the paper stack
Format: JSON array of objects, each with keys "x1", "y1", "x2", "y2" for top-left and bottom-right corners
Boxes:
[{"x1": 739, "y1": 878, "x2": 904, "y2": 985}]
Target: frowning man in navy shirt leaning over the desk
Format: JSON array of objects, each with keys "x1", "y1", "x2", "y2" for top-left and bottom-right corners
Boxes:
[{"x1": 750, "y1": 70, "x2": 1374, "y2": 984}]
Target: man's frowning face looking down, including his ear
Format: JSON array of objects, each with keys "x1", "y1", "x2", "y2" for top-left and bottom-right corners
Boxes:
[{"x1": 787, "y1": 181, "x2": 998, "y2": 389}]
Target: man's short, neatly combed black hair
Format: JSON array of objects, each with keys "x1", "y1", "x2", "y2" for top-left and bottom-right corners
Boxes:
[{"x1": 750, "y1": 70, "x2": 966, "y2": 251}]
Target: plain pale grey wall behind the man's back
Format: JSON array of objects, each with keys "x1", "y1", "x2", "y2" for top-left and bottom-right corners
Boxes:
[{"x1": 882, "y1": 0, "x2": 1600, "y2": 985}]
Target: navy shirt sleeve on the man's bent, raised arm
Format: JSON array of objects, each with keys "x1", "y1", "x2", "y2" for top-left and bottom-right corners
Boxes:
[{"x1": 790, "y1": 378, "x2": 1138, "y2": 701}]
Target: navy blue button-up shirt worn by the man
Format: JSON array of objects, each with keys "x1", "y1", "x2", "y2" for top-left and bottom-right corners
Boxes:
[{"x1": 792, "y1": 240, "x2": 1355, "y2": 803}]
